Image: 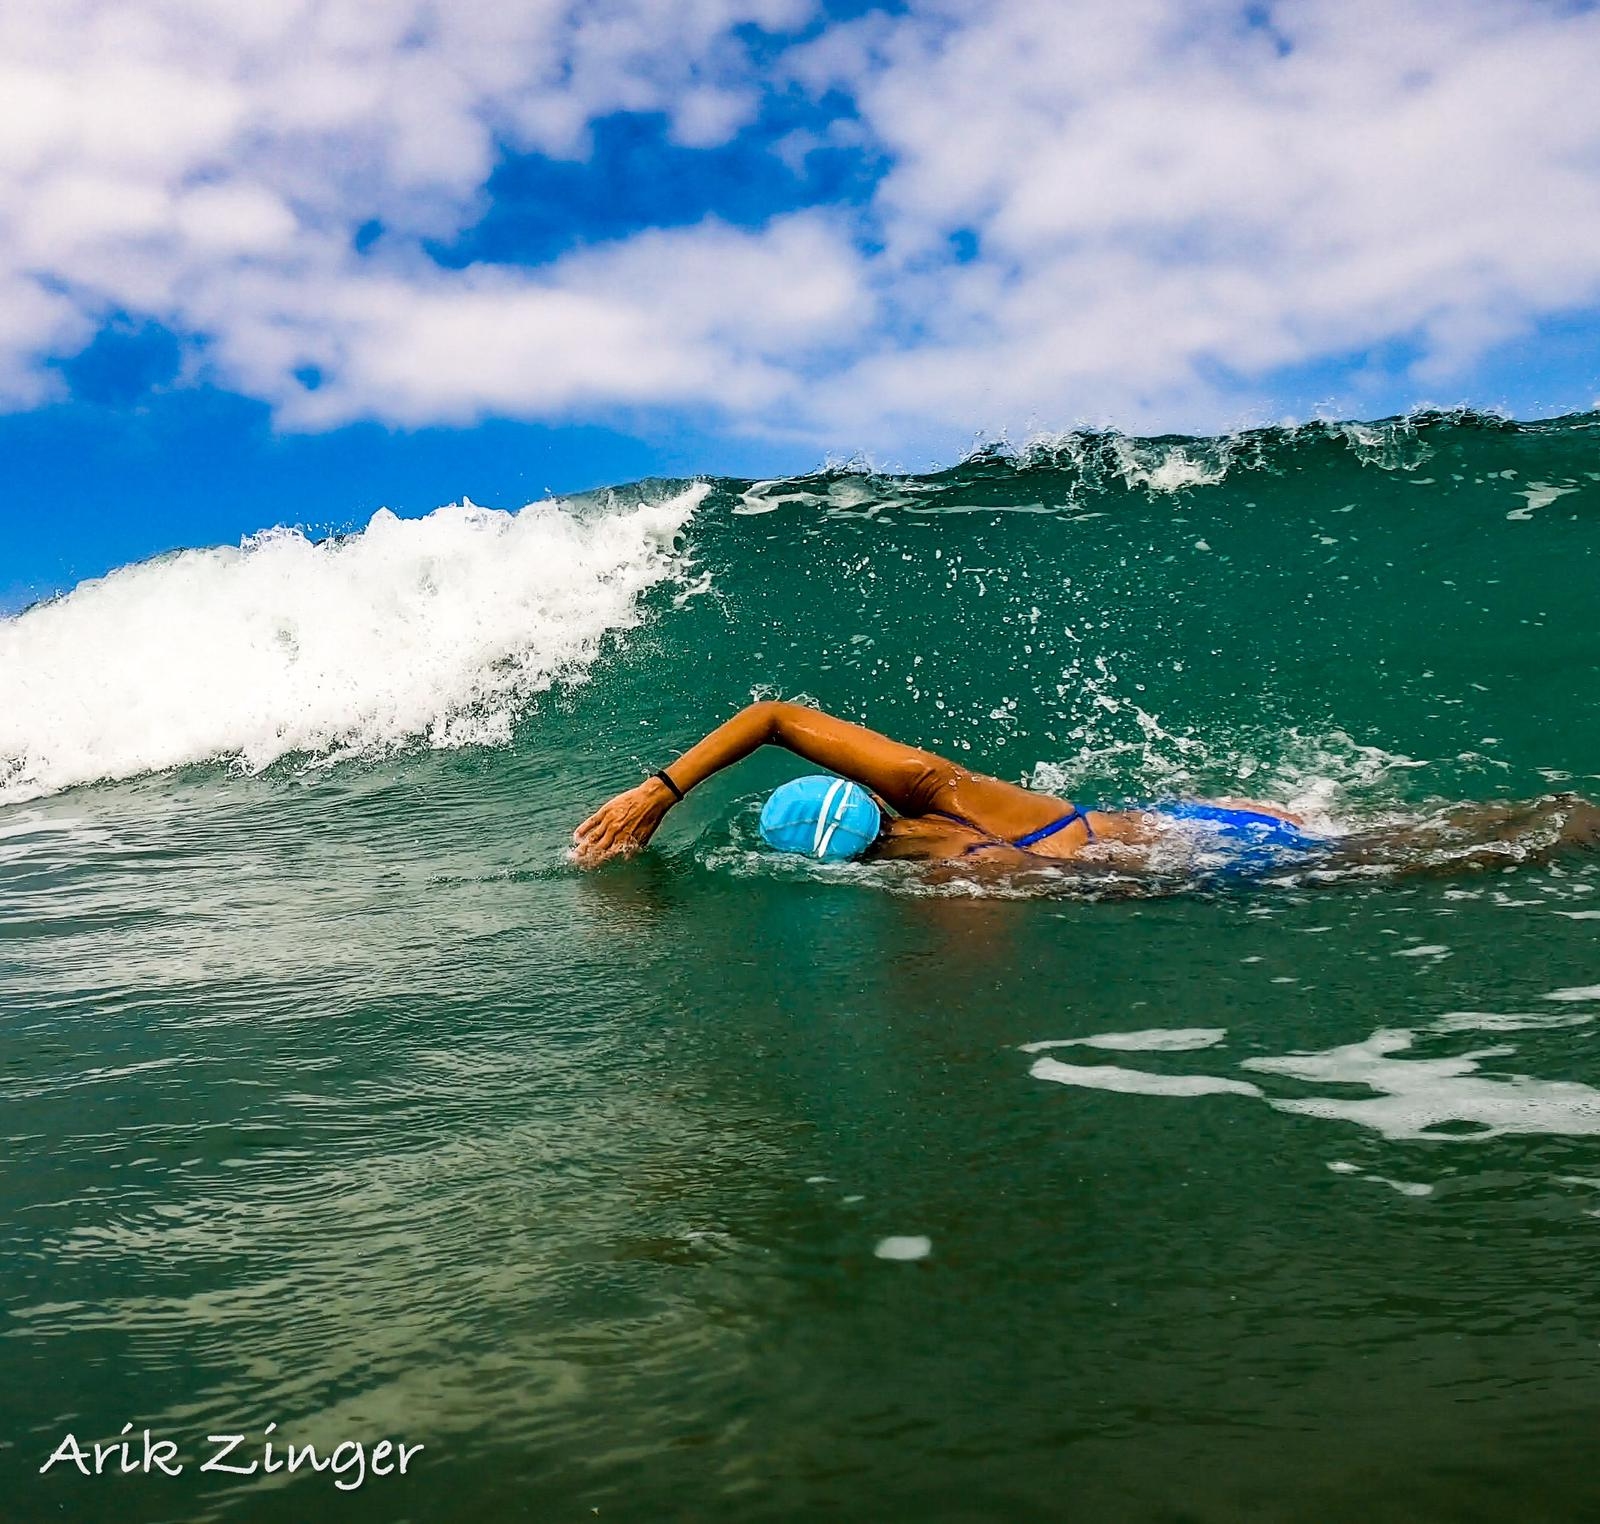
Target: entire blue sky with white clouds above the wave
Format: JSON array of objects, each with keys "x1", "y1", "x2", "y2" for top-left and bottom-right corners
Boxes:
[{"x1": 0, "y1": 0, "x2": 1600, "y2": 610}]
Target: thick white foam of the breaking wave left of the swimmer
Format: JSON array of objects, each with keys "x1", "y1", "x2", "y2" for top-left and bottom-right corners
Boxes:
[{"x1": 0, "y1": 487, "x2": 709, "y2": 802}]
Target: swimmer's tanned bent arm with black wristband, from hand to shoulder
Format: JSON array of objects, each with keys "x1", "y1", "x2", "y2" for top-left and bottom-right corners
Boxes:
[{"x1": 573, "y1": 703, "x2": 1059, "y2": 868}]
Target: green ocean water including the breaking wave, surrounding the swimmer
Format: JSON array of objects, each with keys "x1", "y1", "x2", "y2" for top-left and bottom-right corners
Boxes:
[{"x1": 0, "y1": 415, "x2": 1600, "y2": 1524}]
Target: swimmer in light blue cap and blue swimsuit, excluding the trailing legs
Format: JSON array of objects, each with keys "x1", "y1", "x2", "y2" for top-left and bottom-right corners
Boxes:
[{"x1": 573, "y1": 703, "x2": 1326, "y2": 871}]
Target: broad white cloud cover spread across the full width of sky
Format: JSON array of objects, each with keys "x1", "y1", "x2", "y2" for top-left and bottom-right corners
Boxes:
[{"x1": 0, "y1": 0, "x2": 1600, "y2": 448}]
